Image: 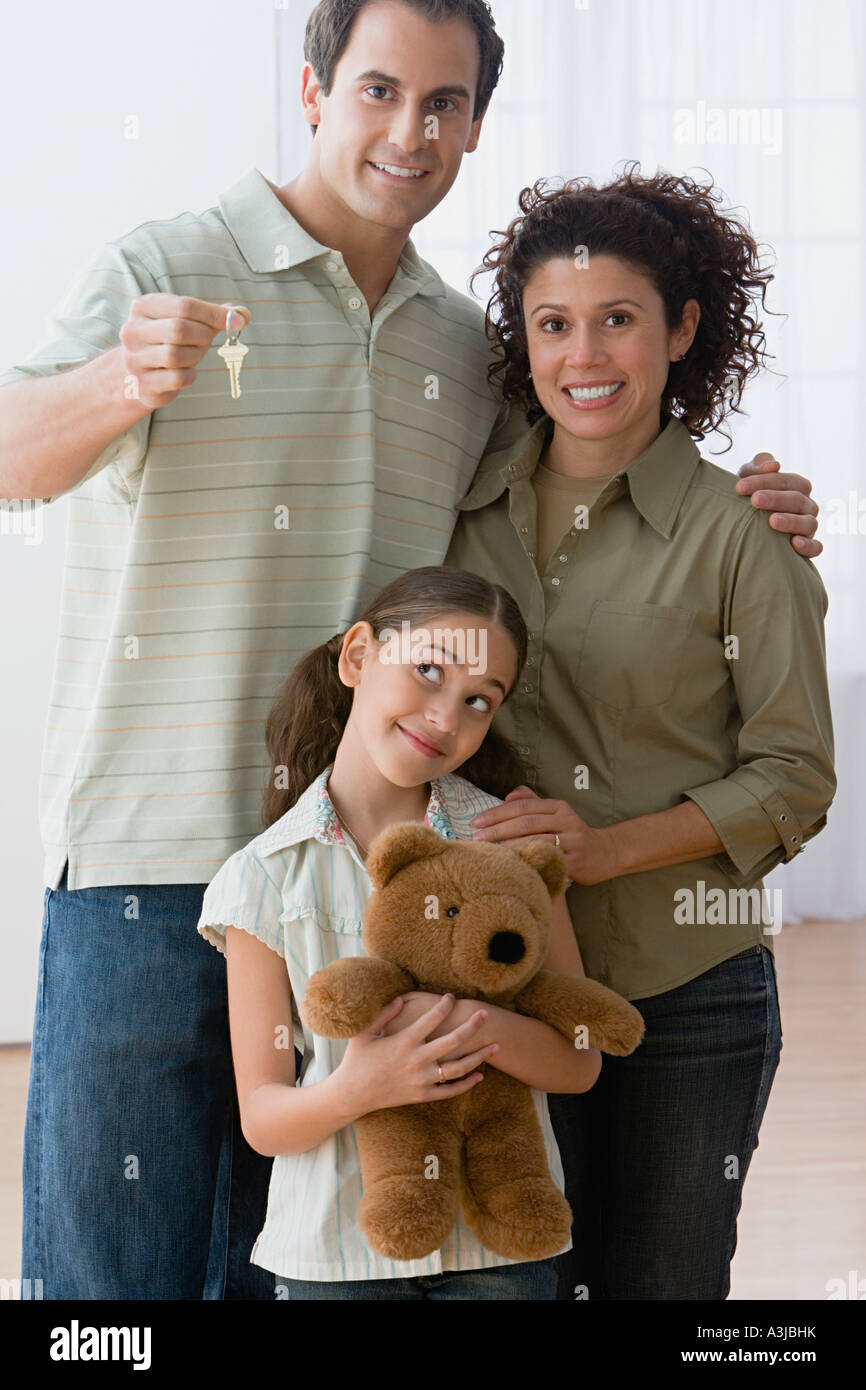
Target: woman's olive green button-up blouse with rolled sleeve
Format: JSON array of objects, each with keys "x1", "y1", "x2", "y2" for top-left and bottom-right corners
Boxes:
[{"x1": 445, "y1": 417, "x2": 835, "y2": 999}]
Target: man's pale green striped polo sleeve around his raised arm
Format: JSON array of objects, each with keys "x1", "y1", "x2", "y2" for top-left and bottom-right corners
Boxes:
[{"x1": 0, "y1": 242, "x2": 160, "y2": 510}]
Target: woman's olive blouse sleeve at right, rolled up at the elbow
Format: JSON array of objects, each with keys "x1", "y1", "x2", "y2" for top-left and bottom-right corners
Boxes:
[{"x1": 683, "y1": 513, "x2": 835, "y2": 885}]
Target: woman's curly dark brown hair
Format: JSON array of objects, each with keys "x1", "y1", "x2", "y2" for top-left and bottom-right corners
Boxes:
[{"x1": 470, "y1": 160, "x2": 774, "y2": 448}]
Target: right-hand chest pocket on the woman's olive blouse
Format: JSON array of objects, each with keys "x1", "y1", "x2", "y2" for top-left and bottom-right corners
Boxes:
[{"x1": 575, "y1": 599, "x2": 694, "y2": 710}]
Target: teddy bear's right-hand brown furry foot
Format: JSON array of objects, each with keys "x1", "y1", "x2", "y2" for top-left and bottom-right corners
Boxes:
[{"x1": 464, "y1": 1177, "x2": 571, "y2": 1259}]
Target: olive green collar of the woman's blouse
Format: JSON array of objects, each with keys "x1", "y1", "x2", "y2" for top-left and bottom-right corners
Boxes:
[{"x1": 457, "y1": 405, "x2": 701, "y2": 539}]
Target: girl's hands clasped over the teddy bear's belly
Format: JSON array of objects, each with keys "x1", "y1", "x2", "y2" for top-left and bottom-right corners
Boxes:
[{"x1": 332, "y1": 994, "x2": 499, "y2": 1115}]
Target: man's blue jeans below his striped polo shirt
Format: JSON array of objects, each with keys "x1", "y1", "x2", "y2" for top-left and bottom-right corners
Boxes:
[{"x1": 21, "y1": 870, "x2": 274, "y2": 1301}]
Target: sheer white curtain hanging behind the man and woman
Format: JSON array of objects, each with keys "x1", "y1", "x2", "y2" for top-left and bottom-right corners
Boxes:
[{"x1": 277, "y1": 0, "x2": 866, "y2": 920}]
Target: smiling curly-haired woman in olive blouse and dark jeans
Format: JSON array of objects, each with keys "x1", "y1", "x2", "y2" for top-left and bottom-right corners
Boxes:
[{"x1": 430, "y1": 167, "x2": 835, "y2": 1300}]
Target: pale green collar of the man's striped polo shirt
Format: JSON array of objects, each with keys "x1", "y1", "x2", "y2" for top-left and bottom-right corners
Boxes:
[{"x1": 218, "y1": 165, "x2": 446, "y2": 296}]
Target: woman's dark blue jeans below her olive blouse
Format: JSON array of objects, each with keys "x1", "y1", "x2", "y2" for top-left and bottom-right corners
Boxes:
[{"x1": 548, "y1": 945, "x2": 781, "y2": 1300}]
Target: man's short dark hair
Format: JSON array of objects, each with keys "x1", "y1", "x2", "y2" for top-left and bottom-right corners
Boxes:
[{"x1": 303, "y1": 0, "x2": 505, "y2": 121}]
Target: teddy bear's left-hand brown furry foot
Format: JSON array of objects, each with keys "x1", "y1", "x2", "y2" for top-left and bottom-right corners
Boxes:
[{"x1": 359, "y1": 1177, "x2": 459, "y2": 1259}]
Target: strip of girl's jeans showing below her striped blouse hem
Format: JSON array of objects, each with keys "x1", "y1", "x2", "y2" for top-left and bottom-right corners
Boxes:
[{"x1": 277, "y1": 1259, "x2": 556, "y2": 1302}]
